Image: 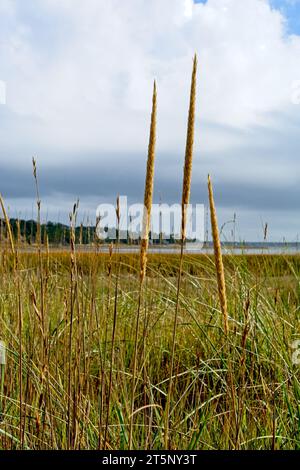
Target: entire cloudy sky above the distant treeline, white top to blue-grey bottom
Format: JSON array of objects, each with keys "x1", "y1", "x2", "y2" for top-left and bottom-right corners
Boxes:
[{"x1": 0, "y1": 0, "x2": 300, "y2": 241}]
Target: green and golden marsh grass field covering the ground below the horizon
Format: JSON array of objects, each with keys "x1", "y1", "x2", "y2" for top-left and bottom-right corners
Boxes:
[{"x1": 0, "y1": 250, "x2": 300, "y2": 449}]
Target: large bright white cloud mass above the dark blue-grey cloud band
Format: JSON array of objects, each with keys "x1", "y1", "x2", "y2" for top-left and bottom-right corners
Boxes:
[{"x1": 0, "y1": 0, "x2": 300, "y2": 237}]
